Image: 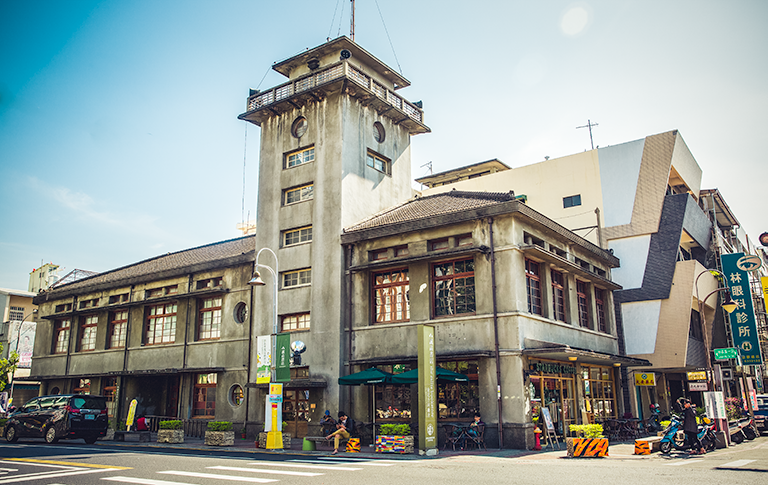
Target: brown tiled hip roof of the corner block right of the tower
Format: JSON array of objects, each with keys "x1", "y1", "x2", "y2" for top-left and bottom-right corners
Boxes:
[{"x1": 344, "y1": 189, "x2": 515, "y2": 233}]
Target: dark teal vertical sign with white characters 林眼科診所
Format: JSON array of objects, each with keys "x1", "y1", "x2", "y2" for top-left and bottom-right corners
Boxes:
[{"x1": 720, "y1": 253, "x2": 763, "y2": 365}]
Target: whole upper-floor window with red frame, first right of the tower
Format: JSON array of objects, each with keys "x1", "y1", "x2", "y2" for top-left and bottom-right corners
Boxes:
[{"x1": 371, "y1": 267, "x2": 411, "y2": 325}]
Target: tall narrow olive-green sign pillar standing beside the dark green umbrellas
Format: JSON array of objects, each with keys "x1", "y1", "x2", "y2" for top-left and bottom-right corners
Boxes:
[{"x1": 418, "y1": 325, "x2": 437, "y2": 454}]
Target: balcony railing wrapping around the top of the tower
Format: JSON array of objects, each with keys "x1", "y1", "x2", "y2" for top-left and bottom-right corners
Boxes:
[{"x1": 247, "y1": 61, "x2": 424, "y2": 123}]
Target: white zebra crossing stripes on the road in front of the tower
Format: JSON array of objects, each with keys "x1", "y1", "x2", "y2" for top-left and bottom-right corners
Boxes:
[{"x1": 101, "y1": 457, "x2": 402, "y2": 485}]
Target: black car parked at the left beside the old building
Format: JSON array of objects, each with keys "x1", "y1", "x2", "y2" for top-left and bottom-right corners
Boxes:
[{"x1": 5, "y1": 394, "x2": 108, "y2": 444}]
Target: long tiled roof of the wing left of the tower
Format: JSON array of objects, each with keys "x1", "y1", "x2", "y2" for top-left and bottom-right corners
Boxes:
[{"x1": 38, "y1": 235, "x2": 255, "y2": 296}]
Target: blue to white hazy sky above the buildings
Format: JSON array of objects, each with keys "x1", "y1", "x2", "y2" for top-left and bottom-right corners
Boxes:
[{"x1": 0, "y1": 0, "x2": 768, "y2": 290}]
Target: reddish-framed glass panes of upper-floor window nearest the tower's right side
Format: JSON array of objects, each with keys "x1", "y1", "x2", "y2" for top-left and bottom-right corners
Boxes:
[{"x1": 373, "y1": 268, "x2": 411, "y2": 323}]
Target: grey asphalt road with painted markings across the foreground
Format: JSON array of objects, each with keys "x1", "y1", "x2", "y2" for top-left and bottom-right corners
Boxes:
[{"x1": 0, "y1": 437, "x2": 768, "y2": 485}]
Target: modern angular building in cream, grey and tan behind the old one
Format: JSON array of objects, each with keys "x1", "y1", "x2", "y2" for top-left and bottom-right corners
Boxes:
[{"x1": 418, "y1": 130, "x2": 750, "y2": 417}]
